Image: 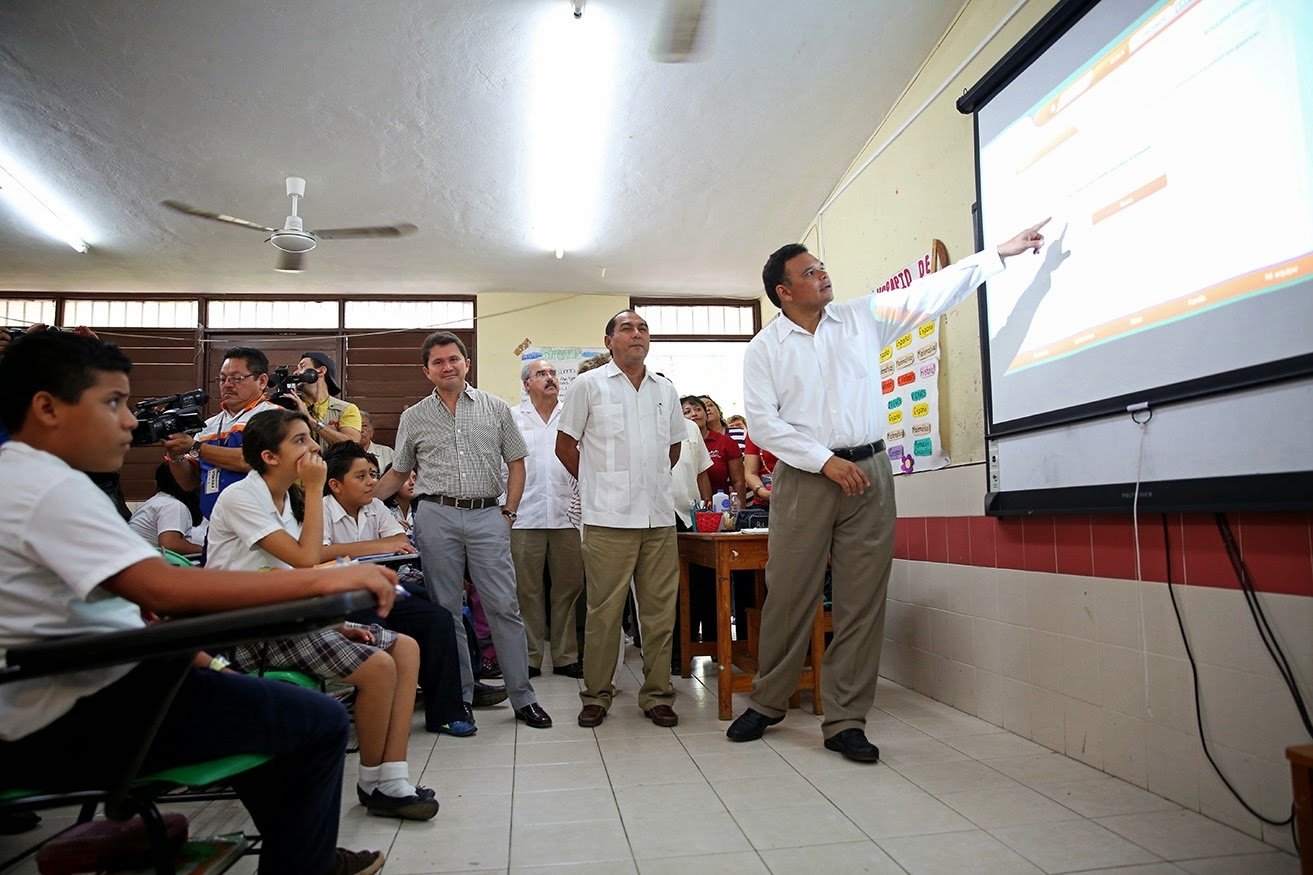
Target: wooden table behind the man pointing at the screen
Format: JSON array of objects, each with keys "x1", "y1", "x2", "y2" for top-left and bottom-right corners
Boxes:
[{"x1": 679, "y1": 532, "x2": 825, "y2": 720}]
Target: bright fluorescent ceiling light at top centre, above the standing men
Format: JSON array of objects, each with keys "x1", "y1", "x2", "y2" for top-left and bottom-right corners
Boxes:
[{"x1": 528, "y1": 3, "x2": 616, "y2": 258}]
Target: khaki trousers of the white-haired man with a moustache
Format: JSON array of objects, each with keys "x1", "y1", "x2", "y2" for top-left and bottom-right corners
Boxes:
[{"x1": 511, "y1": 528, "x2": 583, "y2": 669}]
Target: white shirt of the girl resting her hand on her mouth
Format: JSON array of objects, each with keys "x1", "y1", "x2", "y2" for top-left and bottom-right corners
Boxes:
[{"x1": 205, "y1": 470, "x2": 301, "y2": 572}]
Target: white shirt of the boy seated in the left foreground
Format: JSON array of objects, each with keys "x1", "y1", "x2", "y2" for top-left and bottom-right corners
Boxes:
[{"x1": 0, "y1": 440, "x2": 159, "y2": 741}]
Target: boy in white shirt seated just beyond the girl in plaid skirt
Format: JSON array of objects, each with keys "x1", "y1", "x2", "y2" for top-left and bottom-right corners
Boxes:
[{"x1": 323, "y1": 441, "x2": 478, "y2": 738}]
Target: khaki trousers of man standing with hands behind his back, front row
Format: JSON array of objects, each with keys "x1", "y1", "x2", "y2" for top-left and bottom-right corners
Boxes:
[{"x1": 579, "y1": 526, "x2": 679, "y2": 711}]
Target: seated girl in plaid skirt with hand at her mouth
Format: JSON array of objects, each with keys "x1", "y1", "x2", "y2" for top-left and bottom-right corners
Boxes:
[{"x1": 206, "y1": 410, "x2": 437, "y2": 820}]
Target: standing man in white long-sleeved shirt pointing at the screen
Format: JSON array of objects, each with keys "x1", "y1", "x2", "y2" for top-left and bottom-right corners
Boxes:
[{"x1": 726, "y1": 219, "x2": 1048, "y2": 762}]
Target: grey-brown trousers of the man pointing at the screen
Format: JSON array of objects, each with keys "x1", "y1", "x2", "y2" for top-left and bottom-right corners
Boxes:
[{"x1": 752, "y1": 453, "x2": 895, "y2": 738}]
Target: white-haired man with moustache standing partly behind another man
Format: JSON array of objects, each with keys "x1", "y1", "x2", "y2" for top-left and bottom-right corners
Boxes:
[{"x1": 511, "y1": 359, "x2": 583, "y2": 678}]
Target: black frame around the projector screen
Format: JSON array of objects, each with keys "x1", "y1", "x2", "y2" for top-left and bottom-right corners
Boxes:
[{"x1": 956, "y1": 0, "x2": 1313, "y2": 516}]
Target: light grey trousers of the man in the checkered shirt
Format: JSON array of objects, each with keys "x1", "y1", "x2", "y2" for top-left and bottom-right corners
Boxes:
[{"x1": 415, "y1": 502, "x2": 537, "y2": 708}]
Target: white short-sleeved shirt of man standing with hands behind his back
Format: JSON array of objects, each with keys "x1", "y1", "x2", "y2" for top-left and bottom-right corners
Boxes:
[{"x1": 557, "y1": 361, "x2": 688, "y2": 528}]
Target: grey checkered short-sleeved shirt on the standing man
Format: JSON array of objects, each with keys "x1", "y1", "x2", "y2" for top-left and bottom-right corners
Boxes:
[{"x1": 393, "y1": 384, "x2": 529, "y2": 498}]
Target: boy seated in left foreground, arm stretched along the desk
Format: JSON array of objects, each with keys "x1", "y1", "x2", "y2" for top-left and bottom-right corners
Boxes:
[{"x1": 0, "y1": 331, "x2": 394, "y2": 875}]
